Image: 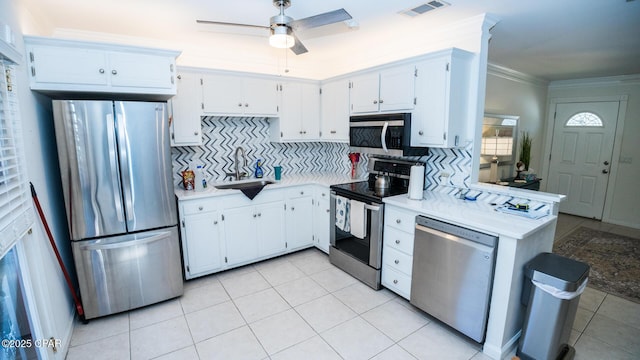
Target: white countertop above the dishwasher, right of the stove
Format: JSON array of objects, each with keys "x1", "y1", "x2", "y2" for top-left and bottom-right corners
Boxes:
[{"x1": 384, "y1": 191, "x2": 557, "y2": 239}]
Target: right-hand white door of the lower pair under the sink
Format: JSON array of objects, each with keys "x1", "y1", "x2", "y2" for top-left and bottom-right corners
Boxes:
[{"x1": 256, "y1": 201, "x2": 286, "y2": 257}]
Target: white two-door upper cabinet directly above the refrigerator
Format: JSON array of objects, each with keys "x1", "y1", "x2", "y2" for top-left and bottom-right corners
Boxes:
[{"x1": 25, "y1": 36, "x2": 180, "y2": 96}]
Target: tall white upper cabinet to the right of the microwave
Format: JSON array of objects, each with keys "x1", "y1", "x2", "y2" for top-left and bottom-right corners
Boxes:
[{"x1": 411, "y1": 49, "x2": 473, "y2": 148}]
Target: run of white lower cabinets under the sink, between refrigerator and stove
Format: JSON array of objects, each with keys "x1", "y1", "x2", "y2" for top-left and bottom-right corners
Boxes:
[{"x1": 178, "y1": 185, "x2": 329, "y2": 280}]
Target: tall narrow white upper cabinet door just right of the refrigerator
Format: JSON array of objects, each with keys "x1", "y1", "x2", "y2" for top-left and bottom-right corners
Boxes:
[{"x1": 171, "y1": 73, "x2": 202, "y2": 146}]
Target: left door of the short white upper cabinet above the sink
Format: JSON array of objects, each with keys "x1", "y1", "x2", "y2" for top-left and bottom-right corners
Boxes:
[{"x1": 202, "y1": 74, "x2": 244, "y2": 115}]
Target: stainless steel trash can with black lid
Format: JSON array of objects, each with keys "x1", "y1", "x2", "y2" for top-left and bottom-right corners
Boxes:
[{"x1": 516, "y1": 253, "x2": 589, "y2": 360}]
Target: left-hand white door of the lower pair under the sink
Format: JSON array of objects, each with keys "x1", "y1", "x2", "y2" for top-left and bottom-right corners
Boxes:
[{"x1": 223, "y1": 206, "x2": 258, "y2": 265}]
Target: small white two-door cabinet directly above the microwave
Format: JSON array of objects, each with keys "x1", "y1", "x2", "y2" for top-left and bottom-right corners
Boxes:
[{"x1": 351, "y1": 65, "x2": 416, "y2": 114}]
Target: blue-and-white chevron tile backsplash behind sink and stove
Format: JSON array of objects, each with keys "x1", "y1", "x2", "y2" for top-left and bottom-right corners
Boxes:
[{"x1": 171, "y1": 116, "x2": 472, "y2": 193}]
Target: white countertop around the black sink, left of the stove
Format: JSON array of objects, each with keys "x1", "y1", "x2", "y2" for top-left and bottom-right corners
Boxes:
[{"x1": 175, "y1": 172, "x2": 365, "y2": 200}]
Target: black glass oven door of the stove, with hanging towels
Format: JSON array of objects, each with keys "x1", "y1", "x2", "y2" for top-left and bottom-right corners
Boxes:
[{"x1": 330, "y1": 191, "x2": 384, "y2": 270}]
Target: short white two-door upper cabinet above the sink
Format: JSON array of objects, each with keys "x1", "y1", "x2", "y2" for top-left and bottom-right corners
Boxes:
[{"x1": 202, "y1": 74, "x2": 278, "y2": 116}]
